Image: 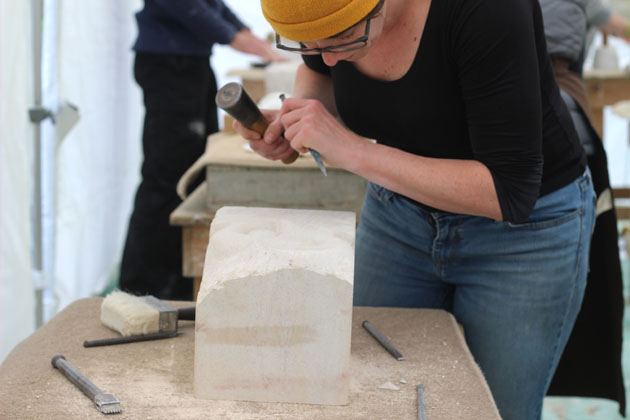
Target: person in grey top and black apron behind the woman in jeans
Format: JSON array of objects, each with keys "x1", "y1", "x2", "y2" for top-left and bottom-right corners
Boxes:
[{"x1": 540, "y1": 0, "x2": 630, "y2": 416}]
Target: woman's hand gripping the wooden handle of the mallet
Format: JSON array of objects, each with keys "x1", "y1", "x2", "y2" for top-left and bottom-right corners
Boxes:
[{"x1": 232, "y1": 110, "x2": 298, "y2": 163}]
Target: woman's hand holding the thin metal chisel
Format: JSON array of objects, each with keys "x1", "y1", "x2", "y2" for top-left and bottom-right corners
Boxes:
[{"x1": 280, "y1": 98, "x2": 366, "y2": 169}]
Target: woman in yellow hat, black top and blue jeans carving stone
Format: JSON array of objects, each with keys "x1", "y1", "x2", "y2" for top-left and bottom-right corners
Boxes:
[{"x1": 234, "y1": 0, "x2": 595, "y2": 420}]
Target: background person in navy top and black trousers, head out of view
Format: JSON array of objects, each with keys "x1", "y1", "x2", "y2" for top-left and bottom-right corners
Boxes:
[{"x1": 119, "y1": 0, "x2": 285, "y2": 300}]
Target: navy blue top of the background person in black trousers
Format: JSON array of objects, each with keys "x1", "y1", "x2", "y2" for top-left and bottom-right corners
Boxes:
[{"x1": 133, "y1": 0, "x2": 245, "y2": 56}]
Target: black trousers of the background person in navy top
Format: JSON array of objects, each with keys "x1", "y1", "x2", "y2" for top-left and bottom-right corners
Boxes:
[{"x1": 120, "y1": 53, "x2": 218, "y2": 300}]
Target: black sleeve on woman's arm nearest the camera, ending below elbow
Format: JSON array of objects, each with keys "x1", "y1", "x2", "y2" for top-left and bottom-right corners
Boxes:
[{"x1": 451, "y1": 0, "x2": 544, "y2": 222}]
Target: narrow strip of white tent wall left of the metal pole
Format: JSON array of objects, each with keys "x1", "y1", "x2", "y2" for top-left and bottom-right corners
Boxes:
[{"x1": 0, "y1": 1, "x2": 35, "y2": 361}]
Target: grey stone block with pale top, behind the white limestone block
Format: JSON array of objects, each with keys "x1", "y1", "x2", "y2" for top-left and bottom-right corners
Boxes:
[{"x1": 206, "y1": 133, "x2": 367, "y2": 214}]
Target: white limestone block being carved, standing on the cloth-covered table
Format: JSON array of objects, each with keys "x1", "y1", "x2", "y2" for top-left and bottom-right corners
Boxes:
[{"x1": 194, "y1": 207, "x2": 355, "y2": 405}]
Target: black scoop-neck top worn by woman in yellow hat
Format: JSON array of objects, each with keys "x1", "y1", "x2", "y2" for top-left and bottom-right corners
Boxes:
[{"x1": 304, "y1": 0, "x2": 586, "y2": 222}]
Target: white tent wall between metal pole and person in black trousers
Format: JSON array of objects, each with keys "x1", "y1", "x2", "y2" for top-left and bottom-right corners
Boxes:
[{"x1": 54, "y1": 0, "x2": 143, "y2": 309}]
